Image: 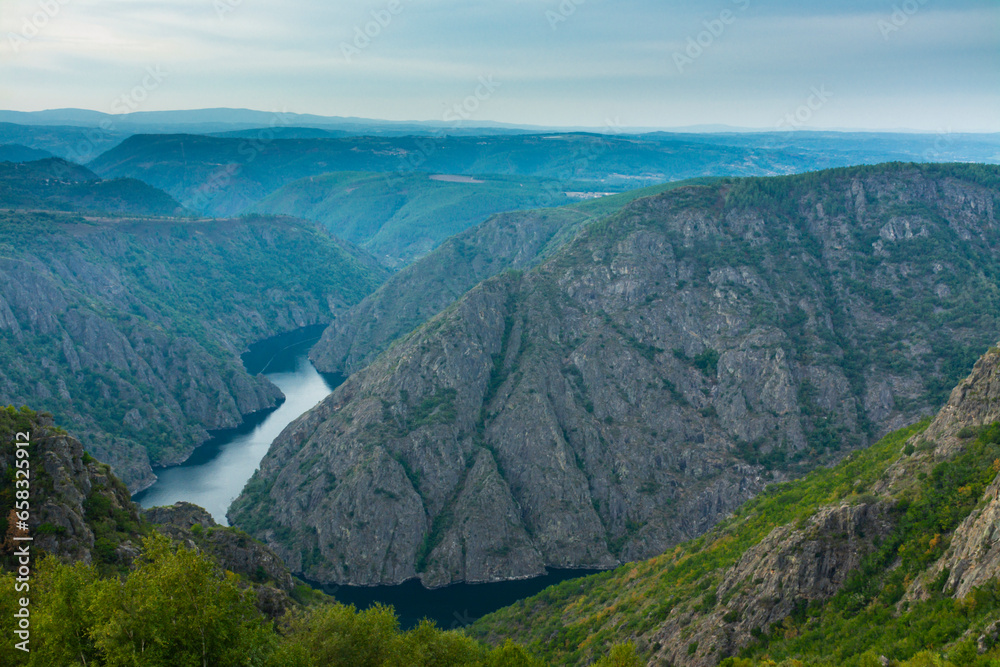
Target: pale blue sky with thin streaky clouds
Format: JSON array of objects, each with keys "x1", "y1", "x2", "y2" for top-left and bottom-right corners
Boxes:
[{"x1": 0, "y1": 0, "x2": 1000, "y2": 132}]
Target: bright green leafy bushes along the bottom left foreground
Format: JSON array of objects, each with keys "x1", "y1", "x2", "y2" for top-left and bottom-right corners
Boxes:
[{"x1": 0, "y1": 535, "x2": 639, "y2": 667}]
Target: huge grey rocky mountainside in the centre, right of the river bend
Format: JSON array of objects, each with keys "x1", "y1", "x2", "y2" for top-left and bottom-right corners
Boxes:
[{"x1": 231, "y1": 165, "x2": 1000, "y2": 585}]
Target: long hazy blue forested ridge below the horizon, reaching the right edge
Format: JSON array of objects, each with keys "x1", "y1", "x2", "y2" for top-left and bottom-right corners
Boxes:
[{"x1": 88, "y1": 129, "x2": 1000, "y2": 223}]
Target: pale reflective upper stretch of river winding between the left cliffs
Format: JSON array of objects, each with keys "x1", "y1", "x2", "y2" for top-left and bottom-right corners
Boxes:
[{"x1": 133, "y1": 327, "x2": 342, "y2": 526}]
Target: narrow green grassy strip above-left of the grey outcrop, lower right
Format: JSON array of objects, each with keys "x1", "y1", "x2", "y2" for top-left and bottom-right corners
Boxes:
[{"x1": 469, "y1": 422, "x2": 927, "y2": 664}]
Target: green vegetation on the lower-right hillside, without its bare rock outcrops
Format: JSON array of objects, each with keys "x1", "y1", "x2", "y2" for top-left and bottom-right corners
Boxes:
[{"x1": 470, "y1": 348, "x2": 1000, "y2": 667}]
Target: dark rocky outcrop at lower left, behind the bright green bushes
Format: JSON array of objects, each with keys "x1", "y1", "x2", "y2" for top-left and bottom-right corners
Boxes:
[{"x1": 0, "y1": 408, "x2": 293, "y2": 617}]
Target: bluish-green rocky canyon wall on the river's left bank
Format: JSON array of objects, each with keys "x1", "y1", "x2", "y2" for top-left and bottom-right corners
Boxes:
[{"x1": 0, "y1": 213, "x2": 383, "y2": 491}]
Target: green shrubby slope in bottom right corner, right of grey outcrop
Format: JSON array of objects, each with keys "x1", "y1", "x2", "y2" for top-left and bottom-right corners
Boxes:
[{"x1": 724, "y1": 424, "x2": 1000, "y2": 667}]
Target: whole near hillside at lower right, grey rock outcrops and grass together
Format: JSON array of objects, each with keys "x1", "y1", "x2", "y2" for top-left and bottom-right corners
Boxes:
[{"x1": 474, "y1": 348, "x2": 1000, "y2": 667}]
